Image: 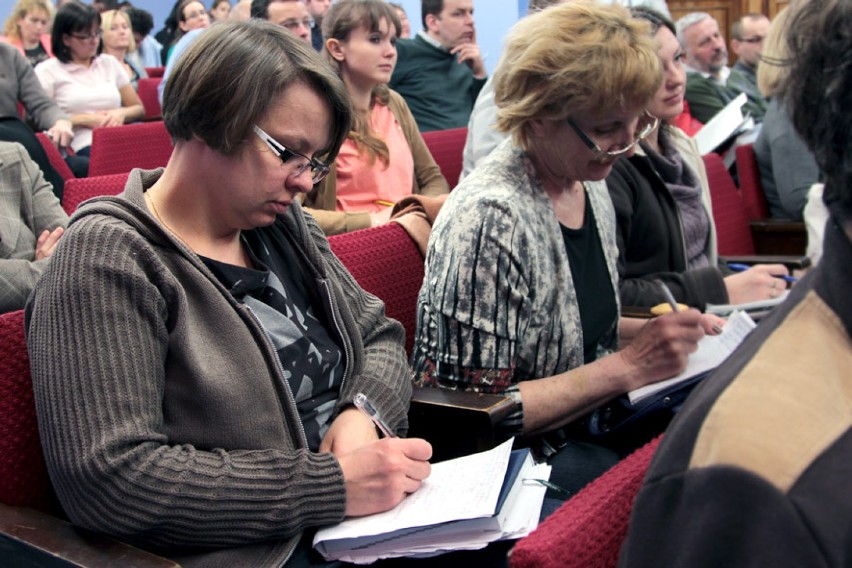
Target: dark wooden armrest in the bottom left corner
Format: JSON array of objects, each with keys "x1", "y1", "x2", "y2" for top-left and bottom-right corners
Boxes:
[{"x1": 0, "y1": 503, "x2": 180, "y2": 568}]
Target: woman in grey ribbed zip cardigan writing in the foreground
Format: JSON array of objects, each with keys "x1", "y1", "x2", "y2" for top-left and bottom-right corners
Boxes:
[{"x1": 28, "y1": 20, "x2": 431, "y2": 566}]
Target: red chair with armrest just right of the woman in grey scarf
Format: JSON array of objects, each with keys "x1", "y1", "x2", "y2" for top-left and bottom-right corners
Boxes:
[{"x1": 702, "y1": 153, "x2": 809, "y2": 270}]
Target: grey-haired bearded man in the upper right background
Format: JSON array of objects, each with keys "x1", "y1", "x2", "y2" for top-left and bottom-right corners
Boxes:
[{"x1": 675, "y1": 12, "x2": 766, "y2": 124}]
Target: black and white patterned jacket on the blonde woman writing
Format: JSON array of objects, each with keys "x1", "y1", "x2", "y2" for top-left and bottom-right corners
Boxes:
[{"x1": 412, "y1": 140, "x2": 621, "y2": 440}]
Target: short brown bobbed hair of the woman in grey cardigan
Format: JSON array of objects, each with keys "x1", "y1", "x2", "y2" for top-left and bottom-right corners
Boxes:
[{"x1": 163, "y1": 20, "x2": 352, "y2": 161}]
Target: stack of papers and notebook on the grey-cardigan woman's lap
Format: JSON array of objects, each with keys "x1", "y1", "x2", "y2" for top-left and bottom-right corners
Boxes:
[{"x1": 313, "y1": 440, "x2": 550, "y2": 564}]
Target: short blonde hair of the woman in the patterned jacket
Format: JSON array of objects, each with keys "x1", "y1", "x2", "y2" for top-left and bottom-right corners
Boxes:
[{"x1": 494, "y1": 0, "x2": 663, "y2": 149}]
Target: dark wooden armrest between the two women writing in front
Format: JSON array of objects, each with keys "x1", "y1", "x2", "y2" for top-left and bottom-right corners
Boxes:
[{"x1": 408, "y1": 387, "x2": 515, "y2": 462}]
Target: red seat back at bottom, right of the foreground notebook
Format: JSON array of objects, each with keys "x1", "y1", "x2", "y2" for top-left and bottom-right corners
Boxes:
[{"x1": 509, "y1": 436, "x2": 661, "y2": 568}]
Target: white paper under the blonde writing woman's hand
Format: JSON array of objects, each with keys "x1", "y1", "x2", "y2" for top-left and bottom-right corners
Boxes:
[{"x1": 628, "y1": 311, "x2": 756, "y2": 404}]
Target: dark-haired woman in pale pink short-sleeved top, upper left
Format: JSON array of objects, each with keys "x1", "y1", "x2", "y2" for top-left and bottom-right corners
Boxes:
[{"x1": 35, "y1": 2, "x2": 145, "y2": 177}]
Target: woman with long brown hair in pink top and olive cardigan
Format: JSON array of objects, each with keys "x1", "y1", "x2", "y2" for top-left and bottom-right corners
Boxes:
[{"x1": 304, "y1": 0, "x2": 449, "y2": 234}]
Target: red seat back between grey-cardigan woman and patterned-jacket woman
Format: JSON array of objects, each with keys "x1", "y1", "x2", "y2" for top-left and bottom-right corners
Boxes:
[{"x1": 328, "y1": 223, "x2": 423, "y2": 354}]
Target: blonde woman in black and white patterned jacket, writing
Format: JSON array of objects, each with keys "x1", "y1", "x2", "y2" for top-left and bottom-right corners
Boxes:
[{"x1": 412, "y1": 1, "x2": 709, "y2": 489}]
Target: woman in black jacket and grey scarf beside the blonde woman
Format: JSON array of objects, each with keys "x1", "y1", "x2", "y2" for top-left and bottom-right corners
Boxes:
[{"x1": 606, "y1": 7, "x2": 787, "y2": 310}]
